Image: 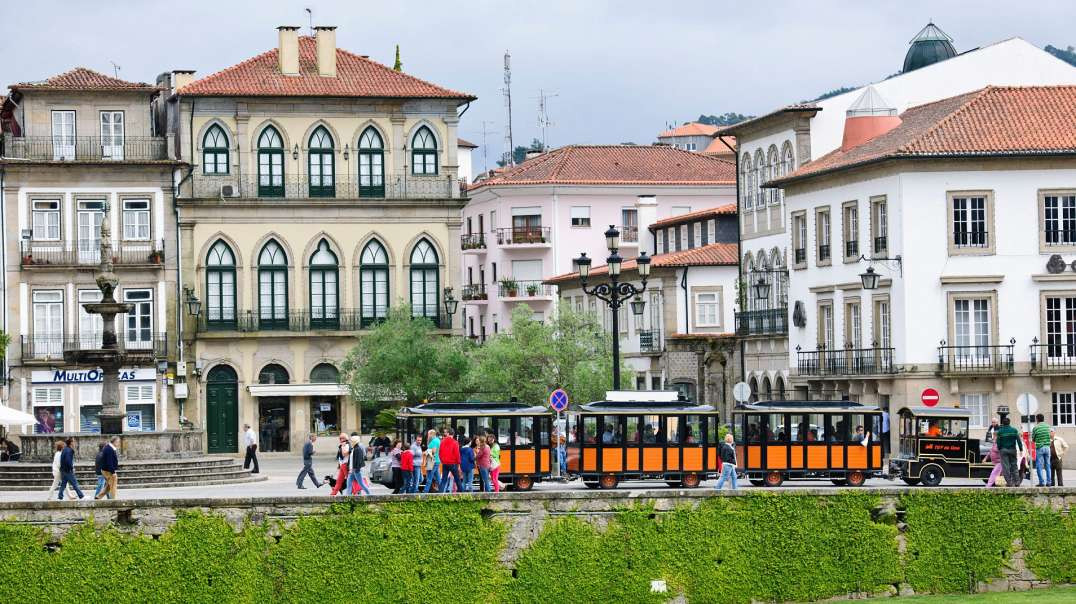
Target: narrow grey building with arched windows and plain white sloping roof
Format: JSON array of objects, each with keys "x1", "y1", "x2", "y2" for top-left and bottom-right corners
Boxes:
[{"x1": 721, "y1": 24, "x2": 1076, "y2": 398}]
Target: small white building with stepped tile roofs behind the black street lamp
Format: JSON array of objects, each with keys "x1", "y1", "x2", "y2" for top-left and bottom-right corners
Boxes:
[{"x1": 548, "y1": 196, "x2": 739, "y2": 412}]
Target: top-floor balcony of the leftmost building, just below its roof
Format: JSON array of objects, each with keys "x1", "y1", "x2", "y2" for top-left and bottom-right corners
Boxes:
[{"x1": 0, "y1": 135, "x2": 168, "y2": 161}]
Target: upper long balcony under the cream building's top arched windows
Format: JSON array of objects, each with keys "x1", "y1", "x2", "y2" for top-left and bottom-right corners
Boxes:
[{"x1": 186, "y1": 173, "x2": 465, "y2": 199}]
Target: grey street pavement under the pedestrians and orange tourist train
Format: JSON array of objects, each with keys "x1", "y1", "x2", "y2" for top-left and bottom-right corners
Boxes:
[{"x1": 0, "y1": 453, "x2": 1076, "y2": 502}]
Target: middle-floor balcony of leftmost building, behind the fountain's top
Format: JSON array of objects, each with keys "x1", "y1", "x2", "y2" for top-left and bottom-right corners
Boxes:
[{"x1": 18, "y1": 239, "x2": 165, "y2": 269}]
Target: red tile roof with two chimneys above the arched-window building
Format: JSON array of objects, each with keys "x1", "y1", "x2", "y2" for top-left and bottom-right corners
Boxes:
[{"x1": 179, "y1": 36, "x2": 476, "y2": 100}]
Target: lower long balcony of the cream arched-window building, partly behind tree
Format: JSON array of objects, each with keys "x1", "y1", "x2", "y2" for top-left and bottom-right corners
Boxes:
[{"x1": 198, "y1": 308, "x2": 451, "y2": 334}]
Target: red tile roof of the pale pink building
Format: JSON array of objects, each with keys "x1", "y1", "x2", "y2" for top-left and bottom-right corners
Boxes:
[{"x1": 471, "y1": 144, "x2": 736, "y2": 189}]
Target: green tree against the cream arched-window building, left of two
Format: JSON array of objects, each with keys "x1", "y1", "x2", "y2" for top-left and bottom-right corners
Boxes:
[{"x1": 342, "y1": 306, "x2": 469, "y2": 407}]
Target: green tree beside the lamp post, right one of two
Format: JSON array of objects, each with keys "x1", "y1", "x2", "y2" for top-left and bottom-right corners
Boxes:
[{"x1": 467, "y1": 305, "x2": 632, "y2": 405}]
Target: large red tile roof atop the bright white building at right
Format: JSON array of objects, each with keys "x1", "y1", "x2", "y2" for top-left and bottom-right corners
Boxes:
[{"x1": 771, "y1": 86, "x2": 1076, "y2": 184}]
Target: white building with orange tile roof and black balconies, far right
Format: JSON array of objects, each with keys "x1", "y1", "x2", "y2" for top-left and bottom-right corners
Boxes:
[{"x1": 774, "y1": 83, "x2": 1076, "y2": 452}]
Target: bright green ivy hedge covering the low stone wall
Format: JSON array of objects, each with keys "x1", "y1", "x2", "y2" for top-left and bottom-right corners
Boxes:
[{"x1": 0, "y1": 491, "x2": 1076, "y2": 603}]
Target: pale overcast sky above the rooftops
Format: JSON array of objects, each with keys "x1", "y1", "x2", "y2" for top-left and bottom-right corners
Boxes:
[{"x1": 0, "y1": 0, "x2": 1076, "y2": 169}]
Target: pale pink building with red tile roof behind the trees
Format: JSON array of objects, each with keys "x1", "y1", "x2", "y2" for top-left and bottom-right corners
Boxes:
[{"x1": 462, "y1": 145, "x2": 735, "y2": 341}]
